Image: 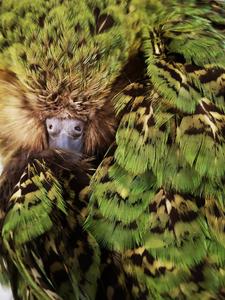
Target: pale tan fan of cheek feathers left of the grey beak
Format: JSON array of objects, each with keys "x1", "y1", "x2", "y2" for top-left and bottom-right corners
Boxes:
[{"x1": 0, "y1": 71, "x2": 45, "y2": 163}]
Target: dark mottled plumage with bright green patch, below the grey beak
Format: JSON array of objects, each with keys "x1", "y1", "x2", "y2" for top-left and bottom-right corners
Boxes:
[{"x1": 0, "y1": 150, "x2": 147, "y2": 300}]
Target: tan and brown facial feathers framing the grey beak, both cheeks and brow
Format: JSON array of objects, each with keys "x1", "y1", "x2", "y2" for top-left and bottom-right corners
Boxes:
[{"x1": 0, "y1": 70, "x2": 116, "y2": 161}]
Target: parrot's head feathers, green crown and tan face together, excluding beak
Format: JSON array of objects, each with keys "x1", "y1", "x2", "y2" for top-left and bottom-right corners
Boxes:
[{"x1": 0, "y1": 0, "x2": 137, "y2": 164}]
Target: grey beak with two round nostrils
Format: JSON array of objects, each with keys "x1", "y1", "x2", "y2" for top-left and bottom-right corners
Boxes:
[{"x1": 46, "y1": 118, "x2": 84, "y2": 153}]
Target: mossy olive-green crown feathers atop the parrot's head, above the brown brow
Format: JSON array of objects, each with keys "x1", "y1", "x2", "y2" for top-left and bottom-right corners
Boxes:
[{"x1": 0, "y1": 0, "x2": 135, "y2": 88}]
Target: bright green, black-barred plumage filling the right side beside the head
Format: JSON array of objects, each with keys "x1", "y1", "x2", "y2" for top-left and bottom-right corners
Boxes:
[{"x1": 86, "y1": 1, "x2": 225, "y2": 299}]
